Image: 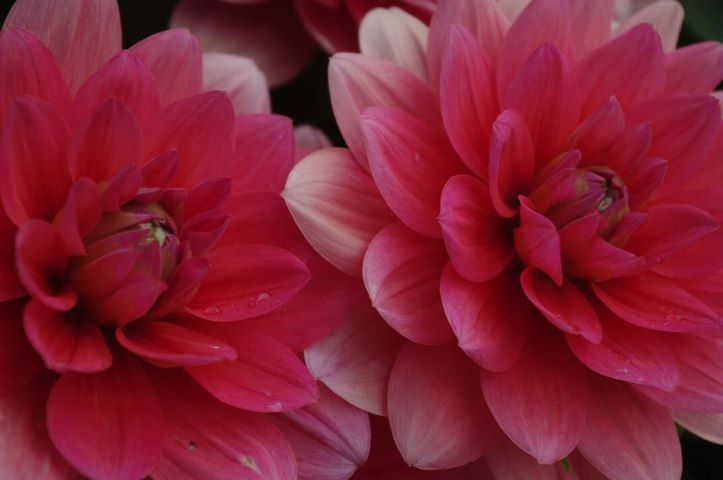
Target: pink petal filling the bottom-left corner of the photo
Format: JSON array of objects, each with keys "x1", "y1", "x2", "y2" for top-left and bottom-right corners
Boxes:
[{"x1": 0, "y1": 374, "x2": 78, "y2": 480}]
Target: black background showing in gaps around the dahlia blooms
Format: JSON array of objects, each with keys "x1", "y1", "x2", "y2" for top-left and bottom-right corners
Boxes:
[{"x1": 0, "y1": 0, "x2": 723, "y2": 480}]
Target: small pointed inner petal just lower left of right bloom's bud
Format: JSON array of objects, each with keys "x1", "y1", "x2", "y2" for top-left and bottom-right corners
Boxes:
[{"x1": 515, "y1": 197, "x2": 563, "y2": 285}]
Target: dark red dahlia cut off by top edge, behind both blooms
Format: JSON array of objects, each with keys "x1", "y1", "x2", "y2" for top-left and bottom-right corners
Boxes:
[{"x1": 171, "y1": 0, "x2": 437, "y2": 86}]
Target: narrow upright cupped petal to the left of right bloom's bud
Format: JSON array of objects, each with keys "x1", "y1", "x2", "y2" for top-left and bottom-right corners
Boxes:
[{"x1": 489, "y1": 110, "x2": 535, "y2": 217}]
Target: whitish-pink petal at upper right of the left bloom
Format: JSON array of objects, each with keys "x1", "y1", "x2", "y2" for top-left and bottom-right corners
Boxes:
[{"x1": 203, "y1": 53, "x2": 271, "y2": 115}]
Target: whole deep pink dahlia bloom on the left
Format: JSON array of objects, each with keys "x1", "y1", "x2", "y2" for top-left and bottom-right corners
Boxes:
[{"x1": 0, "y1": 0, "x2": 356, "y2": 479}]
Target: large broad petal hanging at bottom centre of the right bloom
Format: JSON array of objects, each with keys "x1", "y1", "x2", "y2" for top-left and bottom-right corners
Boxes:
[{"x1": 481, "y1": 327, "x2": 587, "y2": 464}]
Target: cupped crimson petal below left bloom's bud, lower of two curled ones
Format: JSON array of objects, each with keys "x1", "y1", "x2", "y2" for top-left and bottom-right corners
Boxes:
[{"x1": 23, "y1": 300, "x2": 113, "y2": 373}]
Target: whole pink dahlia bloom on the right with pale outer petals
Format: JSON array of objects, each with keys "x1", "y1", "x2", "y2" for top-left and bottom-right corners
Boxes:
[{"x1": 283, "y1": 0, "x2": 723, "y2": 479}]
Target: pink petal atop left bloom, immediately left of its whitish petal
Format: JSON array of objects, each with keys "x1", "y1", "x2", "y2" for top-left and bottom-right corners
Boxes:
[{"x1": 130, "y1": 29, "x2": 203, "y2": 106}]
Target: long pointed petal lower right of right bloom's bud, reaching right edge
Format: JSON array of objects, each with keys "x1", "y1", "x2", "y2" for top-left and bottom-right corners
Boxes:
[{"x1": 593, "y1": 273, "x2": 723, "y2": 332}]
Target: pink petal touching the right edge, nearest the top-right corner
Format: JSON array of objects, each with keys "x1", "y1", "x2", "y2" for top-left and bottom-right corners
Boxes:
[{"x1": 665, "y1": 42, "x2": 723, "y2": 93}]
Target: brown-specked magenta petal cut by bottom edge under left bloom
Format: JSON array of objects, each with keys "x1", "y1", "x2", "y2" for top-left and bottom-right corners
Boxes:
[{"x1": 151, "y1": 371, "x2": 296, "y2": 480}]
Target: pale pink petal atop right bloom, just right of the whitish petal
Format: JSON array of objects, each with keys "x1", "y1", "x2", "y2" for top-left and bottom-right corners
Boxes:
[{"x1": 427, "y1": 0, "x2": 510, "y2": 86}]
